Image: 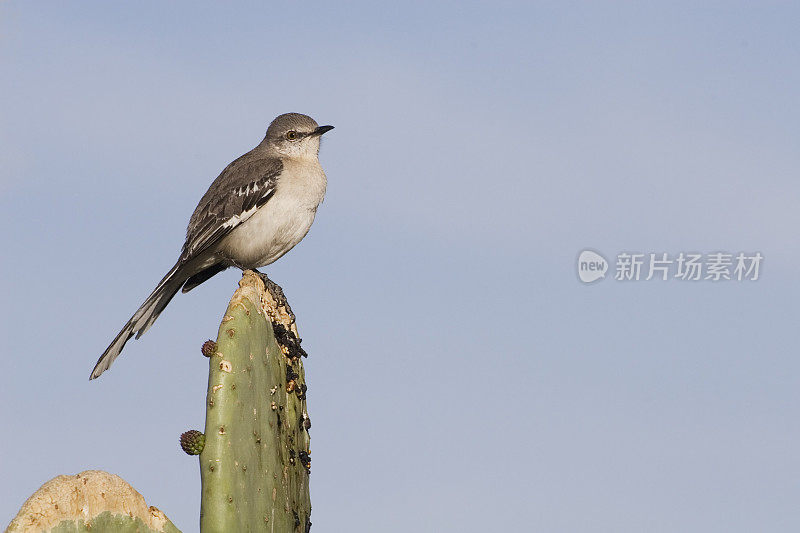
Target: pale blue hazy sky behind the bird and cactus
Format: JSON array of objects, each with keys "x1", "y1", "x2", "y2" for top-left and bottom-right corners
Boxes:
[{"x1": 0, "y1": 1, "x2": 800, "y2": 533}]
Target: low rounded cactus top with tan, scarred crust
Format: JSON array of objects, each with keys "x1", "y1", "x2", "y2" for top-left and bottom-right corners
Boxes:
[{"x1": 6, "y1": 470, "x2": 180, "y2": 533}]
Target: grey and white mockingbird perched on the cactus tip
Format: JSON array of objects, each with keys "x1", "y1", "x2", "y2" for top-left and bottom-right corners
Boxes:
[{"x1": 89, "y1": 113, "x2": 333, "y2": 379}]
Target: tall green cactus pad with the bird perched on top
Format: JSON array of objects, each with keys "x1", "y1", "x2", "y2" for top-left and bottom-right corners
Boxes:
[{"x1": 200, "y1": 271, "x2": 311, "y2": 533}]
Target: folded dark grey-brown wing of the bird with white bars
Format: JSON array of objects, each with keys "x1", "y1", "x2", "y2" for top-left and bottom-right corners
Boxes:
[{"x1": 181, "y1": 153, "x2": 283, "y2": 260}]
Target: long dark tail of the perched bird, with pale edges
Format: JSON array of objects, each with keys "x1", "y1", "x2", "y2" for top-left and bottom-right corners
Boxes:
[{"x1": 89, "y1": 261, "x2": 191, "y2": 380}]
